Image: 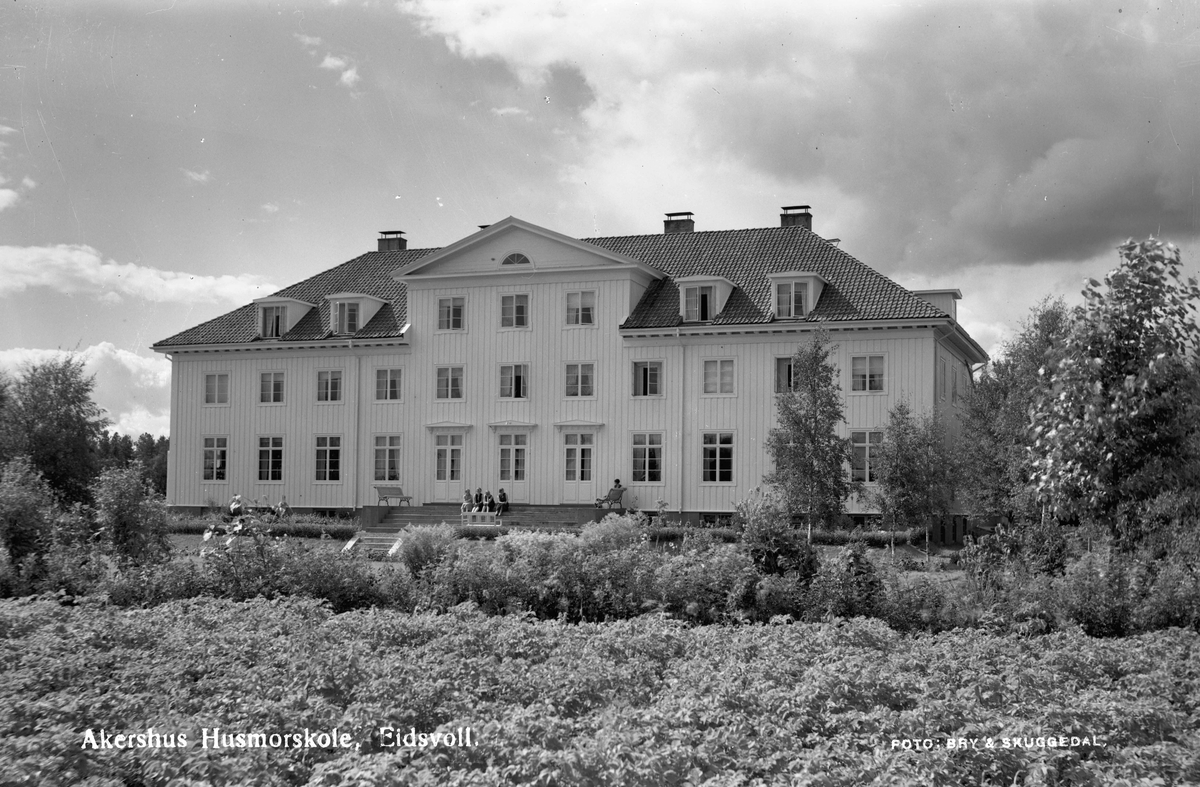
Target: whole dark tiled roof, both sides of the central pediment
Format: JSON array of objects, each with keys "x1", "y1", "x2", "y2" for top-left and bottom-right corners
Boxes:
[{"x1": 155, "y1": 227, "x2": 946, "y2": 348}]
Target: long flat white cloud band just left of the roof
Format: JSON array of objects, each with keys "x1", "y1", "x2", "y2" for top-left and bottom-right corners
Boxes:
[{"x1": 0, "y1": 245, "x2": 278, "y2": 305}]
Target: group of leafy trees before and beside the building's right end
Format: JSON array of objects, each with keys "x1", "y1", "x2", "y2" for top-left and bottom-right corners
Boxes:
[{"x1": 764, "y1": 239, "x2": 1200, "y2": 551}]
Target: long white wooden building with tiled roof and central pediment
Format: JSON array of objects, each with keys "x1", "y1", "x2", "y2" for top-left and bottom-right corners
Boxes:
[{"x1": 154, "y1": 206, "x2": 986, "y2": 527}]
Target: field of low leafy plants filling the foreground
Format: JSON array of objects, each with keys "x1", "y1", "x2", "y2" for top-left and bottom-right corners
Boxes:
[{"x1": 0, "y1": 599, "x2": 1200, "y2": 787}]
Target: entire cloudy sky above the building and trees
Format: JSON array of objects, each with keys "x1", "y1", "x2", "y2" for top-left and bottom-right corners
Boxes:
[{"x1": 0, "y1": 0, "x2": 1200, "y2": 437}]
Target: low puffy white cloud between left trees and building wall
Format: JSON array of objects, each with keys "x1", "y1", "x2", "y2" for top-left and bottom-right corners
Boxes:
[{"x1": 0, "y1": 342, "x2": 170, "y2": 437}]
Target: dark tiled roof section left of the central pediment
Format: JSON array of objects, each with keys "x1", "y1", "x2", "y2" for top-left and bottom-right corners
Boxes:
[{"x1": 155, "y1": 248, "x2": 437, "y2": 348}]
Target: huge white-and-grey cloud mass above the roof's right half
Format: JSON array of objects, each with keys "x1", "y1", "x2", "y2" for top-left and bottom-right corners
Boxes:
[{"x1": 400, "y1": 0, "x2": 1200, "y2": 270}]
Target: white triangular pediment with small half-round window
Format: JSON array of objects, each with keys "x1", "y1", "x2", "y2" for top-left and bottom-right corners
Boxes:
[{"x1": 392, "y1": 216, "x2": 662, "y2": 281}]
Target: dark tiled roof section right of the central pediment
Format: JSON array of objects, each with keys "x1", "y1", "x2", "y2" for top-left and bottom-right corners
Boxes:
[{"x1": 583, "y1": 227, "x2": 946, "y2": 328}]
